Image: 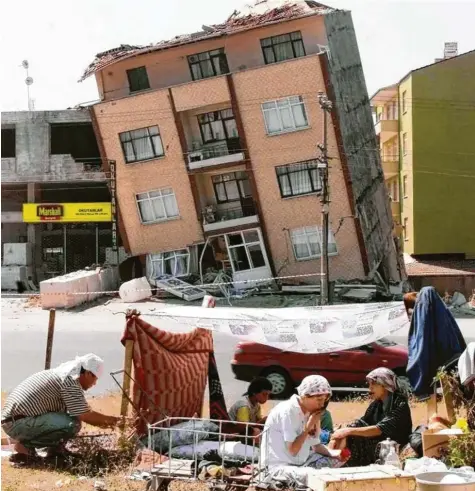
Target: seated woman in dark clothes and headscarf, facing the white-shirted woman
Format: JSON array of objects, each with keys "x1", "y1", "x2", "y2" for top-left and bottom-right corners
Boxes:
[{"x1": 330, "y1": 368, "x2": 412, "y2": 466}]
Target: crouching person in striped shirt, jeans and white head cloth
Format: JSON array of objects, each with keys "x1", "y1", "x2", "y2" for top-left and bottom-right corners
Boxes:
[{"x1": 1, "y1": 353, "x2": 121, "y2": 462}]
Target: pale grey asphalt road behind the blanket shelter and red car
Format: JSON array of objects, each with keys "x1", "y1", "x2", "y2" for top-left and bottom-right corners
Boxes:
[{"x1": 1, "y1": 298, "x2": 475, "y2": 401}]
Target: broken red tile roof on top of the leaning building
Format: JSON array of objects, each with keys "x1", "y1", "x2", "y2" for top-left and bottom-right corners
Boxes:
[{"x1": 79, "y1": 0, "x2": 335, "y2": 82}]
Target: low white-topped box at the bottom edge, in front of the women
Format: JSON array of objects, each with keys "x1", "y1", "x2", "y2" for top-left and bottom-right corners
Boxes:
[{"x1": 307, "y1": 465, "x2": 416, "y2": 491}]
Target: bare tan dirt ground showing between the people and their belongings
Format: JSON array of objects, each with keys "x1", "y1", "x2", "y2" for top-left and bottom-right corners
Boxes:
[{"x1": 1, "y1": 393, "x2": 432, "y2": 491}]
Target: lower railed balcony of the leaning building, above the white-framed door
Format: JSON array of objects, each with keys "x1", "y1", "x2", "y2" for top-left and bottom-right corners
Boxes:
[{"x1": 202, "y1": 199, "x2": 259, "y2": 233}]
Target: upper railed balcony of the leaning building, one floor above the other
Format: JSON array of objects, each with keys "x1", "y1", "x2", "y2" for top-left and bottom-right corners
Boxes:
[{"x1": 188, "y1": 138, "x2": 244, "y2": 170}]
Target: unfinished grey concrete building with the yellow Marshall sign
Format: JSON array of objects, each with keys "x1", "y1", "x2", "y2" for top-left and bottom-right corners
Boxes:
[{"x1": 2, "y1": 110, "x2": 112, "y2": 283}]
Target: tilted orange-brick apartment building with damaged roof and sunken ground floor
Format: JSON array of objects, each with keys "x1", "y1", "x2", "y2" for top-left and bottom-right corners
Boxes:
[{"x1": 83, "y1": 1, "x2": 404, "y2": 283}]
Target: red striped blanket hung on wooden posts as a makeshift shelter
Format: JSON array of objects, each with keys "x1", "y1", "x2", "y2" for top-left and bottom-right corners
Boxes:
[{"x1": 122, "y1": 310, "x2": 232, "y2": 434}]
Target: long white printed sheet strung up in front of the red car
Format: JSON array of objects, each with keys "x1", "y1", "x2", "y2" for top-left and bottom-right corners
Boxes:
[{"x1": 145, "y1": 302, "x2": 409, "y2": 353}]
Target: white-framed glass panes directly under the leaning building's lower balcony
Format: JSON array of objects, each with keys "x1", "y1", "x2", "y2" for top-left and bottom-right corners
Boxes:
[{"x1": 225, "y1": 229, "x2": 266, "y2": 271}]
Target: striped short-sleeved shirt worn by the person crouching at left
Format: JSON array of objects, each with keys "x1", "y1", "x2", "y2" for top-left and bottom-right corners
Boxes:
[{"x1": 2, "y1": 369, "x2": 89, "y2": 421}]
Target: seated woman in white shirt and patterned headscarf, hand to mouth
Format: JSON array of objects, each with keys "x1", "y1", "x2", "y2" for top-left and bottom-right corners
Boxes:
[{"x1": 261, "y1": 375, "x2": 343, "y2": 484}]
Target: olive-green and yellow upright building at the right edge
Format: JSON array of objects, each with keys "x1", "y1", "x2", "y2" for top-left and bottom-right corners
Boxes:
[{"x1": 371, "y1": 48, "x2": 475, "y2": 260}]
